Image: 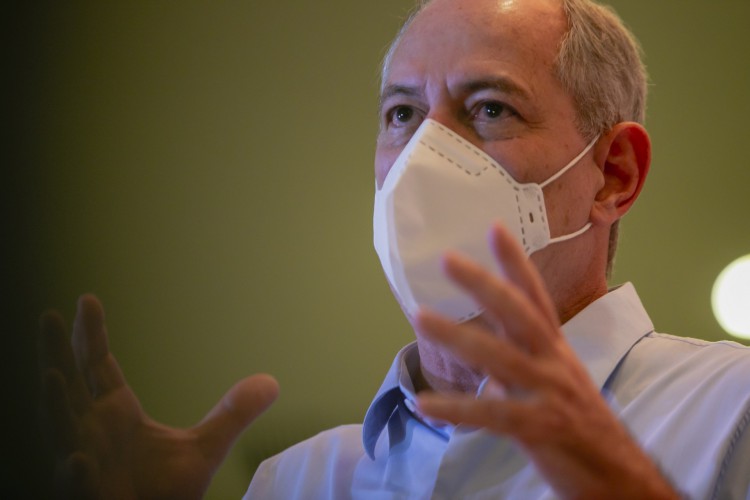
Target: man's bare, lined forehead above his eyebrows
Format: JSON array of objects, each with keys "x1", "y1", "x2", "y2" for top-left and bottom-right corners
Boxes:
[{"x1": 384, "y1": 0, "x2": 566, "y2": 94}]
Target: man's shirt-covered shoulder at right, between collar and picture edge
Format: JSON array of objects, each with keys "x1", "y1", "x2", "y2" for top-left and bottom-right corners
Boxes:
[{"x1": 608, "y1": 333, "x2": 750, "y2": 498}]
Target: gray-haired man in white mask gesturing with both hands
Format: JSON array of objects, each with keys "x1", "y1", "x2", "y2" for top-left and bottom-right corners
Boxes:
[{"x1": 43, "y1": 0, "x2": 750, "y2": 499}]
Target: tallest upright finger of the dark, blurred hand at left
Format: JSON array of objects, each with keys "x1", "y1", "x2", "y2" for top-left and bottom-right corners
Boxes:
[{"x1": 73, "y1": 295, "x2": 125, "y2": 397}]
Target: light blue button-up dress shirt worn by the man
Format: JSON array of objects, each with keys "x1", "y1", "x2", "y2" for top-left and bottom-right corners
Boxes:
[{"x1": 245, "y1": 284, "x2": 750, "y2": 500}]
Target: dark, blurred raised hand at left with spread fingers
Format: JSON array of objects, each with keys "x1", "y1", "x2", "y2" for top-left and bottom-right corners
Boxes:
[{"x1": 39, "y1": 295, "x2": 278, "y2": 499}]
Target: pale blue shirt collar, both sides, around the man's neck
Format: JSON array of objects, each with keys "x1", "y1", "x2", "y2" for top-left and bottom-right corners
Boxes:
[{"x1": 362, "y1": 283, "x2": 654, "y2": 458}]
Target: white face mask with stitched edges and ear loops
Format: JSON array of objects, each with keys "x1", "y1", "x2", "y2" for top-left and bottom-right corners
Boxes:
[{"x1": 373, "y1": 119, "x2": 598, "y2": 322}]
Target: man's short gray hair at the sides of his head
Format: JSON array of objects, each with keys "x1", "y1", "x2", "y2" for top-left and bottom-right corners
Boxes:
[{"x1": 381, "y1": 0, "x2": 648, "y2": 276}]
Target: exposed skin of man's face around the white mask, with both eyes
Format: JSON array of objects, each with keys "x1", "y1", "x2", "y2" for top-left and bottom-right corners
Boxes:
[{"x1": 375, "y1": 0, "x2": 596, "y2": 274}]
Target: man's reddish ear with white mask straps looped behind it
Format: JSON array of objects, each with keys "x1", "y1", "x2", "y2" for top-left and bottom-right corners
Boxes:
[{"x1": 591, "y1": 122, "x2": 651, "y2": 225}]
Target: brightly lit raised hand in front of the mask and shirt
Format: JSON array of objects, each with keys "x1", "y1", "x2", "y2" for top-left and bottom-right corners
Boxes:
[{"x1": 417, "y1": 226, "x2": 678, "y2": 499}]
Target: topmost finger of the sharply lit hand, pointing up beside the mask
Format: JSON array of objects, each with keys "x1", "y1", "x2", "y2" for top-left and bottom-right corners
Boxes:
[{"x1": 490, "y1": 223, "x2": 558, "y2": 328}]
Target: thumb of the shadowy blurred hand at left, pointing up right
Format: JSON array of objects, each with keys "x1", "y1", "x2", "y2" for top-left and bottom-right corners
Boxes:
[{"x1": 193, "y1": 374, "x2": 279, "y2": 465}]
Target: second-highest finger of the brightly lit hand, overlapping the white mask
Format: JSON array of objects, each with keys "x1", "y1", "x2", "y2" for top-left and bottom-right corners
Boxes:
[{"x1": 444, "y1": 252, "x2": 549, "y2": 353}]
